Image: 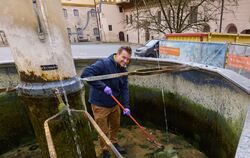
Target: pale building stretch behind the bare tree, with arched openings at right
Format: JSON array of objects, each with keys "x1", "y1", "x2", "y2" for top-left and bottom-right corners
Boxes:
[{"x1": 124, "y1": 0, "x2": 250, "y2": 43}]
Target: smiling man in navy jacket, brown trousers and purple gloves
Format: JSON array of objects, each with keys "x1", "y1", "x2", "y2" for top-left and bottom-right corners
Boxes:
[{"x1": 81, "y1": 46, "x2": 132, "y2": 158}]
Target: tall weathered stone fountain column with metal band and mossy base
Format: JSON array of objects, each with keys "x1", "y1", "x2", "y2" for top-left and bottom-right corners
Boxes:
[{"x1": 0, "y1": 0, "x2": 95, "y2": 157}]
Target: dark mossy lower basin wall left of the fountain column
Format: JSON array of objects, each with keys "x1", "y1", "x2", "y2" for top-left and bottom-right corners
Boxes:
[{"x1": 0, "y1": 92, "x2": 34, "y2": 154}]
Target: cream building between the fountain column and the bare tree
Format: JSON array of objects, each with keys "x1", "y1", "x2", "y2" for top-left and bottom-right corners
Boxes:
[{"x1": 61, "y1": 0, "x2": 129, "y2": 43}]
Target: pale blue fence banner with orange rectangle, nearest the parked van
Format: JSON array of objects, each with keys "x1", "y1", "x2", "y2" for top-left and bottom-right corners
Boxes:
[{"x1": 159, "y1": 41, "x2": 227, "y2": 67}]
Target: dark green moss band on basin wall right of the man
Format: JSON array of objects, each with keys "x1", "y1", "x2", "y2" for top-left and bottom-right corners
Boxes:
[{"x1": 130, "y1": 85, "x2": 240, "y2": 158}]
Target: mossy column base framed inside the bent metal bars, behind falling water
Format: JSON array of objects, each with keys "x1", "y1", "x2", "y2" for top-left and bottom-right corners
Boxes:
[{"x1": 49, "y1": 111, "x2": 96, "y2": 158}]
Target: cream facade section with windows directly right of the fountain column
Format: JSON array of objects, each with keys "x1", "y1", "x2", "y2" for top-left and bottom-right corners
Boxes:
[{"x1": 61, "y1": 0, "x2": 100, "y2": 43}]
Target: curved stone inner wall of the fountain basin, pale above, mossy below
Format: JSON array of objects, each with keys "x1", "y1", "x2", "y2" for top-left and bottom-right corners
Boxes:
[{"x1": 0, "y1": 58, "x2": 250, "y2": 157}]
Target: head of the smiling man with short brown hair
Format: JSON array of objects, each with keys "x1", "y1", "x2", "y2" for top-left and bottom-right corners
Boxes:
[{"x1": 115, "y1": 46, "x2": 132, "y2": 67}]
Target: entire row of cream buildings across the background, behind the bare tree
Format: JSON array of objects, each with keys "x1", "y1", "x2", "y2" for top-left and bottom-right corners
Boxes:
[{"x1": 62, "y1": 0, "x2": 250, "y2": 43}]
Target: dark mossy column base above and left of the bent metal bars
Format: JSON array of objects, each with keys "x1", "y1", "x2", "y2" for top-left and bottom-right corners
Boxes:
[{"x1": 21, "y1": 91, "x2": 89, "y2": 157}]
